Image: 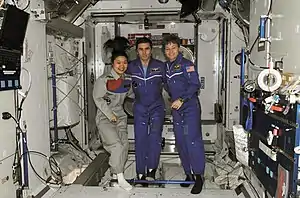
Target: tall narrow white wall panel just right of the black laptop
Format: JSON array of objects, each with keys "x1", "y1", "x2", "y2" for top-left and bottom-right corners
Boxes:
[{"x1": 22, "y1": 20, "x2": 50, "y2": 196}]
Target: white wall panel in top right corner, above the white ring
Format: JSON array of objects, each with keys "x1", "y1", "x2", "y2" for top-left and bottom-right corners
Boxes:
[{"x1": 271, "y1": 0, "x2": 300, "y2": 75}]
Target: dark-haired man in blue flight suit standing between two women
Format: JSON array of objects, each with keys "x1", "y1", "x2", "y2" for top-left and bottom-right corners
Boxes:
[{"x1": 127, "y1": 37, "x2": 165, "y2": 183}]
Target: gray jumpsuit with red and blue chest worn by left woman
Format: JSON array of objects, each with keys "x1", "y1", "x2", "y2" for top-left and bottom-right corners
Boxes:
[{"x1": 93, "y1": 69, "x2": 132, "y2": 174}]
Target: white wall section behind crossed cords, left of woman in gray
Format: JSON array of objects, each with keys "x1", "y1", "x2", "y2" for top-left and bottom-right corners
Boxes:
[{"x1": 47, "y1": 36, "x2": 82, "y2": 127}]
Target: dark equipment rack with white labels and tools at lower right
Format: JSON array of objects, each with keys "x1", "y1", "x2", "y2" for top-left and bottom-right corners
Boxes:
[{"x1": 249, "y1": 96, "x2": 300, "y2": 198}]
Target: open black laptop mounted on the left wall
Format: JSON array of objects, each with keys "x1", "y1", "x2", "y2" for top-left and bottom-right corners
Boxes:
[{"x1": 0, "y1": 5, "x2": 30, "y2": 91}]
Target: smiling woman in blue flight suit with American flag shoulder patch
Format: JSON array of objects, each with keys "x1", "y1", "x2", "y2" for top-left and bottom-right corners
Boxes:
[{"x1": 163, "y1": 35, "x2": 205, "y2": 194}]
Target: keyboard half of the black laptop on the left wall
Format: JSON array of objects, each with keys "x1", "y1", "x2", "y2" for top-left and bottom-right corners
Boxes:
[{"x1": 0, "y1": 48, "x2": 22, "y2": 91}]
